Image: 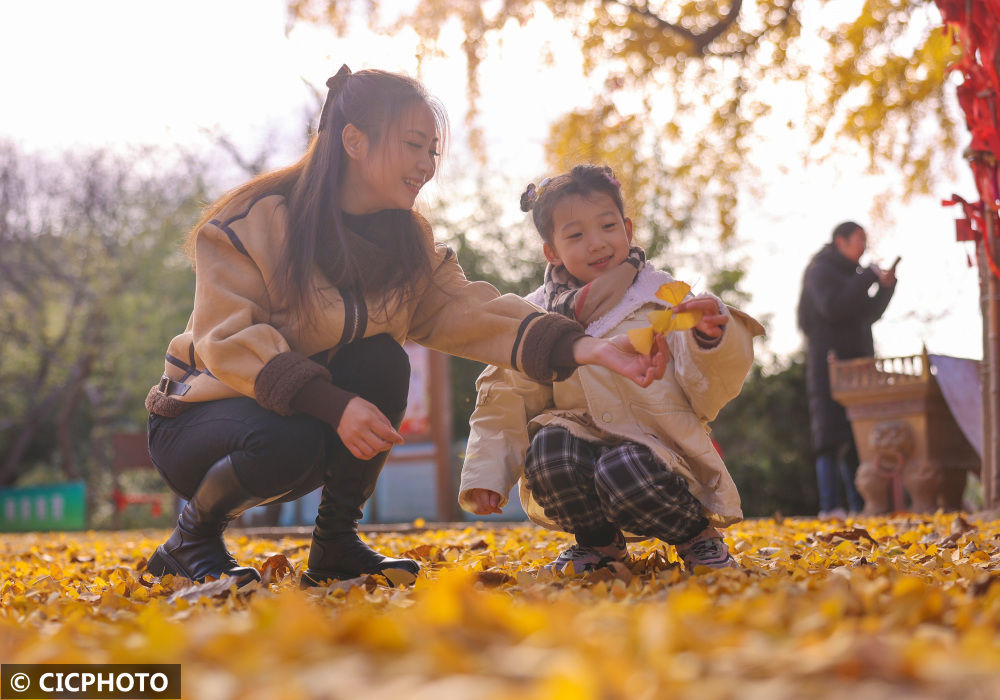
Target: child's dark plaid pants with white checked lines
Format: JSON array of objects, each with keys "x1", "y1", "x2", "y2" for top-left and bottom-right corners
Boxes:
[{"x1": 524, "y1": 426, "x2": 708, "y2": 544}]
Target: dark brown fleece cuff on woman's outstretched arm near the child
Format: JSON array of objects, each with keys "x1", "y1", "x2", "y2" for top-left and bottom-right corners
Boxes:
[{"x1": 512, "y1": 314, "x2": 586, "y2": 382}]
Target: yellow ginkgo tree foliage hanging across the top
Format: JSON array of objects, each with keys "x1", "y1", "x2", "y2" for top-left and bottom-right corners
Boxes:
[{"x1": 288, "y1": 0, "x2": 959, "y2": 242}]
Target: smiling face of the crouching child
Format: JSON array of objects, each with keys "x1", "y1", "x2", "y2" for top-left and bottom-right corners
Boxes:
[{"x1": 543, "y1": 192, "x2": 632, "y2": 284}]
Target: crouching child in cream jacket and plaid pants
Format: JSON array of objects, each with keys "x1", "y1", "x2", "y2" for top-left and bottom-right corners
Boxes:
[{"x1": 459, "y1": 165, "x2": 764, "y2": 573}]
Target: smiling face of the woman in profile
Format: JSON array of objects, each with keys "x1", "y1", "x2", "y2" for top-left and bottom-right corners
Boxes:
[{"x1": 342, "y1": 103, "x2": 438, "y2": 214}]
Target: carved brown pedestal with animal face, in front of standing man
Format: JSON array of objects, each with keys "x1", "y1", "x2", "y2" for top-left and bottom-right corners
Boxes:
[{"x1": 829, "y1": 351, "x2": 980, "y2": 515}]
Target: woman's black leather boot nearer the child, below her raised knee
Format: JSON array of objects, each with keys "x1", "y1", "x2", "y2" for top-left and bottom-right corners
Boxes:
[{"x1": 301, "y1": 414, "x2": 420, "y2": 587}]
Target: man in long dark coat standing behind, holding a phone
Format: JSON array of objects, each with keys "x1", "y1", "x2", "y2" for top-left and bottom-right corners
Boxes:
[{"x1": 798, "y1": 221, "x2": 899, "y2": 518}]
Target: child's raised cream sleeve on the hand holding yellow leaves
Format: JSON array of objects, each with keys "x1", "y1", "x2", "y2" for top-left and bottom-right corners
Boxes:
[{"x1": 667, "y1": 301, "x2": 764, "y2": 421}]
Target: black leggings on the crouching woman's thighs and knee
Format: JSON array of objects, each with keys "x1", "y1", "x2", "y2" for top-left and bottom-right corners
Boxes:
[{"x1": 148, "y1": 335, "x2": 410, "y2": 502}]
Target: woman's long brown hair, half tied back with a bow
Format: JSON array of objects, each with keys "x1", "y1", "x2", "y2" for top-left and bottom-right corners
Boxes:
[{"x1": 185, "y1": 66, "x2": 447, "y2": 320}]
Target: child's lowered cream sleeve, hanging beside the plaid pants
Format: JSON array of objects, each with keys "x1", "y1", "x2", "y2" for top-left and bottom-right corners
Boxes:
[{"x1": 458, "y1": 366, "x2": 552, "y2": 512}]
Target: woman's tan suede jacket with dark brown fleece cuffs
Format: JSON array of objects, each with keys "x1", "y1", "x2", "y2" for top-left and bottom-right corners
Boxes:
[{"x1": 146, "y1": 195, "x2": 581, "y2": 417}]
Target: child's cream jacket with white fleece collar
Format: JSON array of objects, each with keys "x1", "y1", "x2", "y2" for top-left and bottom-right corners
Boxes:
[{"x1": 459, "y1": 265, "x2": 764, "y2": 529}]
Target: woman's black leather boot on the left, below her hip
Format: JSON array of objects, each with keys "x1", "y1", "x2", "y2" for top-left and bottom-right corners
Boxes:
[{"x1": 146, "y1": 455, "x2": 275, "y2": 586}]
